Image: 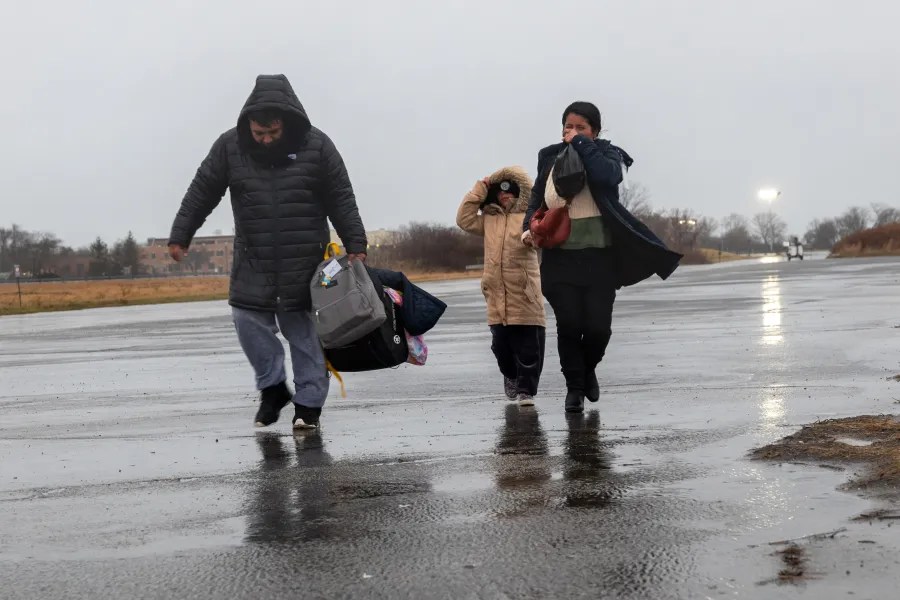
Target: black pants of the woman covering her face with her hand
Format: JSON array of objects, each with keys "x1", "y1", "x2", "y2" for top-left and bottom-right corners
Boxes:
[{"x1": 541, "y1": 248, "x2": 616, "y2": 392}]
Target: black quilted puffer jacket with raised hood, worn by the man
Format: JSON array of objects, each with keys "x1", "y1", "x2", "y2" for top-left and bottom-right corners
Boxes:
[{"x1": 169, "y1": 75, "x2": 367, "y2": 311}]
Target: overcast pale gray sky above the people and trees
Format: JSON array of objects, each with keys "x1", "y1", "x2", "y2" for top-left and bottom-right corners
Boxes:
[{"x1": 0, "y1": 0, "x2": 900, "y2": 245}]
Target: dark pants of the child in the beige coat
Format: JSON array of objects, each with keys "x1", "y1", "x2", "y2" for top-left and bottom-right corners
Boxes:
[{"x1": 491, "y1": 325, "x2": 546, "y2": 396}]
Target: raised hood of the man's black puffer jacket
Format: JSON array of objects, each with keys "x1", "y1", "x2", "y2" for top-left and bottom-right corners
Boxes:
[{"x1": 237, "y1": 75, "x2": 312, "y2": 150}]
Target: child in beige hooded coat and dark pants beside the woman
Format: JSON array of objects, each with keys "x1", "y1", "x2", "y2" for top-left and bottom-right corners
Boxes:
[{"x1": 456, "y1": 167, "x2": 546, "y2": 406}]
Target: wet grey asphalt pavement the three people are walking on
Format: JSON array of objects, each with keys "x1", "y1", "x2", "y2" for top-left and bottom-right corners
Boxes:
[{"x1": 0, "y1": 251, "x2": 900, "y2": 599}]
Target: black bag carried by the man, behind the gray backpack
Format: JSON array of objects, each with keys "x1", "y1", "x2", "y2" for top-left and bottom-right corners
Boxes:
[{"x1": 325, "y1": 288, "x2": 409, "y2": 373}]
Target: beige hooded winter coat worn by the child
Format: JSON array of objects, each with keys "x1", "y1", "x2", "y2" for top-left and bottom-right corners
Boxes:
[{"x1": 456, "y1": 167, "x2": 546, "y2": 326}]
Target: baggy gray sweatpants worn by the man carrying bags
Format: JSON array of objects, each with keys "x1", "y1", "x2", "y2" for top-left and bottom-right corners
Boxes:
[{"x1": 231, "y1": 307, "x2": 328, "y2": 408}]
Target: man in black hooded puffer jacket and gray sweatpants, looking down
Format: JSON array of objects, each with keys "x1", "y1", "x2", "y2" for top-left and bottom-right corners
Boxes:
[{"x1": 169, "y1": 75, "x2": 368, "y2": 429}]
